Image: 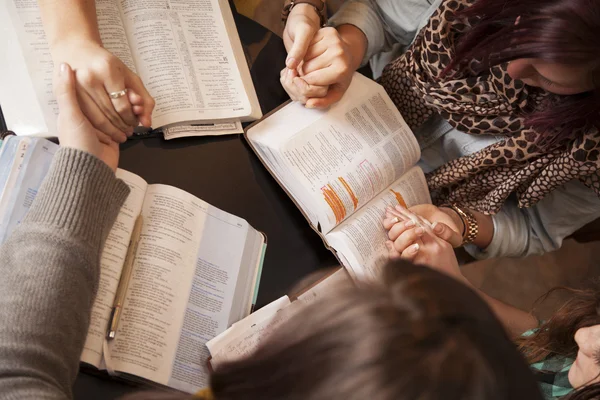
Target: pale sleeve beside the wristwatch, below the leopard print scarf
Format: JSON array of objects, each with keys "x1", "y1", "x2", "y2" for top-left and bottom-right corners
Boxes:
[{"x1": 465, "y1": 181, "x2": 600, "y2": 259}]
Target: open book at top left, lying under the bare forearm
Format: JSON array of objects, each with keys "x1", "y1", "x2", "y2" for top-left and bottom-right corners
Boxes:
[{"x1": 0, "y1": 0, "x2": 262, "y2": 138}]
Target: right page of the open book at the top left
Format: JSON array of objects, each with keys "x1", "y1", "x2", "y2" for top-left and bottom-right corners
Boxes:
[{"x1": 119, "y1": 0, "x2": 251, "y2": 127}]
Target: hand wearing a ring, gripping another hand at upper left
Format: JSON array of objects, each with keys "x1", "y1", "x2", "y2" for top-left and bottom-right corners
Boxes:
[{"x1": 52, "y1": 39, "x2": 154, "y2": 143}]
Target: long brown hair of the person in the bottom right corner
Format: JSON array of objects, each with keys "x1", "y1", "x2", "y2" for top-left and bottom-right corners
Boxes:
[{"x1": 518, "y1": 283, "x2": 600, "y2": 400}]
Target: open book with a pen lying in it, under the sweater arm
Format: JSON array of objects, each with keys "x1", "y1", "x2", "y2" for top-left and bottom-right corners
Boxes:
[{"x1": 0, "y1": 137, "x2": 266, "y2": 393}]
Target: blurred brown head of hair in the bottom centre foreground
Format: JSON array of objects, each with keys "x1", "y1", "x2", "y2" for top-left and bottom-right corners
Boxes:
[{"x1": 210, "y1": 262, "x2": 541, "y2": 400}]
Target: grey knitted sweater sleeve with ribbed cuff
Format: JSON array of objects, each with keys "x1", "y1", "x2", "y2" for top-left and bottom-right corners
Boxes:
[{"x1": 0, "y1": 148, "x2": 129, "y2": 399}]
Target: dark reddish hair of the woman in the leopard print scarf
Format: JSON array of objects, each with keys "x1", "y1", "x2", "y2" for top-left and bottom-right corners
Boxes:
[{"x1": 444, "y1": 0, "x2": 600, "y2": 147}]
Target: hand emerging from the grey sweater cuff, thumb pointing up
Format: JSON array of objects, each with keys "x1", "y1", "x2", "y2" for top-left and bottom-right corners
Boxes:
[{"x1": 54, "y1": 63, "x2": 119, "y2": 171}]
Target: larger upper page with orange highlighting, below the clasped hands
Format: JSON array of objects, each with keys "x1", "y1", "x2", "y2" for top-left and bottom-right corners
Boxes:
[{"x1": 248, "y1": 74, "x2": 420, "y2": 233}]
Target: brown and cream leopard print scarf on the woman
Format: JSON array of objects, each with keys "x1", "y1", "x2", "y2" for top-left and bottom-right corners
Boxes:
[{"x1": 380, "y1": 0, "x2": 600, "y2": 214}]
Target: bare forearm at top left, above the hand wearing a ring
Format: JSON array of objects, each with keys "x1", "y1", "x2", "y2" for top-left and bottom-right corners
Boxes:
[{"x1": 38, "y1": 0, "x2": 102, "y2": 51}]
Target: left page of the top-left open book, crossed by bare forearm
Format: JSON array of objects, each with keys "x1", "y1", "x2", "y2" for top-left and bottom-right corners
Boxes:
[{"x1": 0, "y1": 0, "x2": 136, "y2": 135}]
